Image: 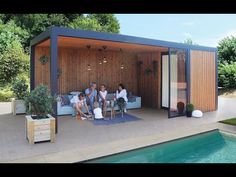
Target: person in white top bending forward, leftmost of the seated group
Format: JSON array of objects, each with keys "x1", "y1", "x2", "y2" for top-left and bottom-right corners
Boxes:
[{"x1": 71, "y1": 93, "x2": 91, "y2": 119}]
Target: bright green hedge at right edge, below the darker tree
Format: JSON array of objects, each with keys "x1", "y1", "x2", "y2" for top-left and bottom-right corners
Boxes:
[{"x1": 218, "y1": 62, "x2": 236, "y2": 88}]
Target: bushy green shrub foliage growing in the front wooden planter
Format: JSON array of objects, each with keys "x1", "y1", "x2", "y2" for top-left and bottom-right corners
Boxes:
[{"x1": 25, "y1": 85, "x2": 56, "y2": 119}]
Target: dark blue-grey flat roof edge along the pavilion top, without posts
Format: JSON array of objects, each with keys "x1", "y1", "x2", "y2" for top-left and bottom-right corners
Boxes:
[{"x1": 30, "y1": 27, "x2": 217, "y2": 52}]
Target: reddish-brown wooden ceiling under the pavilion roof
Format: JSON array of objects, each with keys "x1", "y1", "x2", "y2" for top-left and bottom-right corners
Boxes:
[{"x1": 37, "y1": 36, "x2": 168, "y2": 52}]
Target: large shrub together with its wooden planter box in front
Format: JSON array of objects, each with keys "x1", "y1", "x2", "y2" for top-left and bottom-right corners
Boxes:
[{"x1": 25, "y1": 85, "x2": 56, "y2": 144}]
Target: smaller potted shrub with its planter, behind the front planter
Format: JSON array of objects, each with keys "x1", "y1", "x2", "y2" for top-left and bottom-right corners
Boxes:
[{"x1": 11, "y1": 78, "x2": 29, "y2": 115}]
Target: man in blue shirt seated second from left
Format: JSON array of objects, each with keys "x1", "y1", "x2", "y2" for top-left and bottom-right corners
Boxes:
[{"x1": 85, "y1": 82, "x2": 97, "y2": 113}]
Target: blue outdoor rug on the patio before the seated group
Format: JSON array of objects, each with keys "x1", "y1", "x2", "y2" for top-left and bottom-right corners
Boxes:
[{"x1": 92, "y1": 113, "x2": 142, "y2": 125}]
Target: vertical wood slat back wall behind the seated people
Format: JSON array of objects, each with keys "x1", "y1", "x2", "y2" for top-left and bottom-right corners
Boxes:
[{"x1": 35, "y1": 47, "x2": 137, "y2": 95}]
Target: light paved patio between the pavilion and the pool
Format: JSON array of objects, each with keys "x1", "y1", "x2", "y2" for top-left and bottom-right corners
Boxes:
[{"x1": 0, "y1": 97, "x2": 236, "y2": 162}]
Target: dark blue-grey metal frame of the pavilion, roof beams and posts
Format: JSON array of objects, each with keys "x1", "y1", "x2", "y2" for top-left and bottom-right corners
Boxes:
[{"x1": 30, "y1": 27, "x2": 218, "y2": 130}]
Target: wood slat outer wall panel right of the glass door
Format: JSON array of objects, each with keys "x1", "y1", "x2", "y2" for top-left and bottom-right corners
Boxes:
[{"x1": 190, "y1": 50, "x2": 216, "y2": 112}]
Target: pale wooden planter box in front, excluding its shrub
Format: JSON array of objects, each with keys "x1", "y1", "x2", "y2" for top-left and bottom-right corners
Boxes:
[{"x1": 25, "y1": 114, "x2": 55, "y2": 144}]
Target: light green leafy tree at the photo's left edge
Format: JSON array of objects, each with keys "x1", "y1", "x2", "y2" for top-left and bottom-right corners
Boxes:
[{"x1": 0, "y1": 21, "x2": 29, "y2": 85}]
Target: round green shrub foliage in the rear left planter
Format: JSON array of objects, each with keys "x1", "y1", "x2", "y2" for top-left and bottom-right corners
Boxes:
[{"x1": 11, "y1": 77, "x2": 28, "y2": 100}]
